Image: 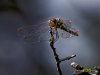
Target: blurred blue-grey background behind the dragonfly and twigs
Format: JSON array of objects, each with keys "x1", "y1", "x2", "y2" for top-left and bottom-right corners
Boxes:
[{"x1": 0, "y1": 0, "x2": 100, "y2": 75}]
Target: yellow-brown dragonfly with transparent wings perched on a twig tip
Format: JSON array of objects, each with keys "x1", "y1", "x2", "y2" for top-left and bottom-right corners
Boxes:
[{"x1": 17, "y1": 18, "x2": 78, "y2": 43}]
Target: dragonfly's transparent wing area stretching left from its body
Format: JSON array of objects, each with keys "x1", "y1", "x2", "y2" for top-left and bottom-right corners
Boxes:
[{"x1": 17, "y1": 22, "x2": 49, "y2": 43}]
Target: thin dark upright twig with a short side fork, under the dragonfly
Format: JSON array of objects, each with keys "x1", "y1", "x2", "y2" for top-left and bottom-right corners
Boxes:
[{"x1": 49, "y1": 29, "x2": 76, "y2": 75}]
